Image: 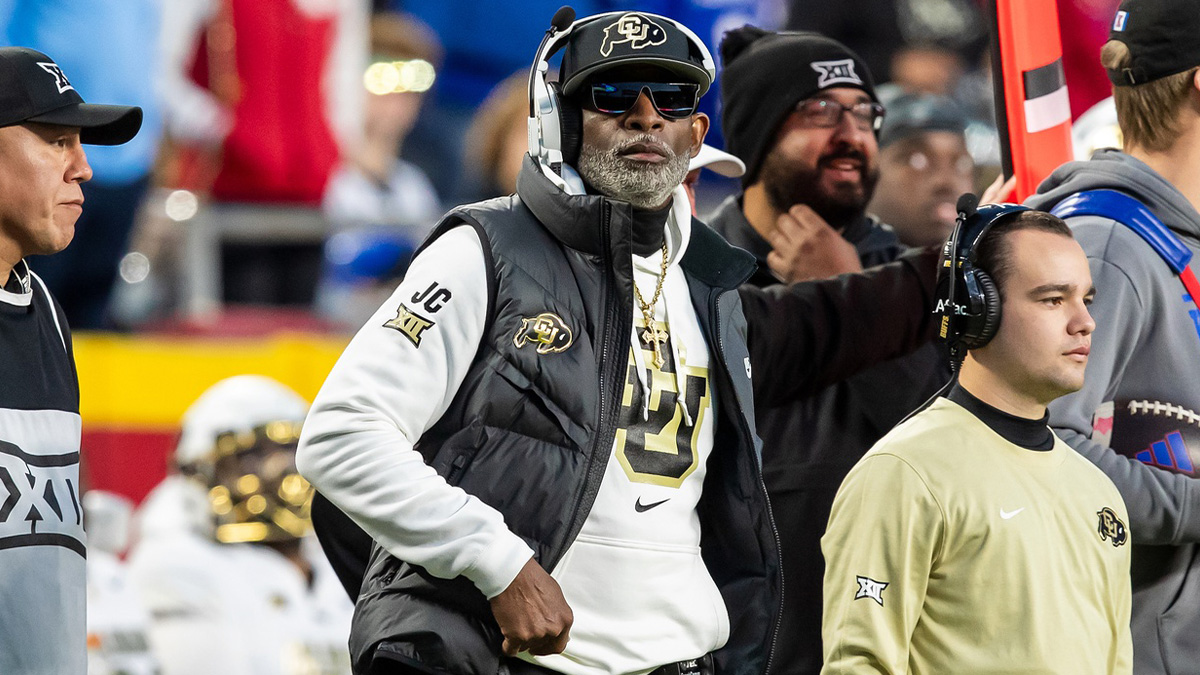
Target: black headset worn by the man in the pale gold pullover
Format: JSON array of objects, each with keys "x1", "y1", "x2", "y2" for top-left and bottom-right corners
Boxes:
[{"x1": 935, "y1": 193, "x2": 1030, "y2": 360}]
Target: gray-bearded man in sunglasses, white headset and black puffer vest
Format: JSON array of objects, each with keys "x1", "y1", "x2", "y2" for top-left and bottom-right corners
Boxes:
[{"x1": 296, "y1": 6, "x2": 936, "y2": 675}]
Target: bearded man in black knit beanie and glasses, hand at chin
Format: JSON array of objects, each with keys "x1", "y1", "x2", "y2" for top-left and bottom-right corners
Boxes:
[{"x1": 708, "y1": 26, "x2": 949, "y2": 674}]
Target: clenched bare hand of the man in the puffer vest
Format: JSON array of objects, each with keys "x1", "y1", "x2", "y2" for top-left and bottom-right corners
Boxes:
[{"x1": 491, "y1": 558, "x2": 575, "y2": 656}]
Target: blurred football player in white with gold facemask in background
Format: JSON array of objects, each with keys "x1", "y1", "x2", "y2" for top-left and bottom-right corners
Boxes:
[{"x1": 131, "y1": 375, "x2": 353, "y2": 675}]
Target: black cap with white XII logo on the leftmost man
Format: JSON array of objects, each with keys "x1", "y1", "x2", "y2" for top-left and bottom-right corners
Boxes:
[{"x1": 0, "y1": 47, "x2": 142, "y2": 145}]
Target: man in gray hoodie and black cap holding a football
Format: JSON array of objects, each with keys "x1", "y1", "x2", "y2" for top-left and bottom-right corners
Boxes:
[{"x1": 1028, "y1": 0, "x2": 1200, "y2": 674}]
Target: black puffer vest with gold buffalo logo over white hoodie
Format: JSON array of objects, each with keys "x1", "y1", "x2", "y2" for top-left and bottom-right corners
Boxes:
[{"x1": 350, "y1": 157, "x2": 781, "y2": 675}]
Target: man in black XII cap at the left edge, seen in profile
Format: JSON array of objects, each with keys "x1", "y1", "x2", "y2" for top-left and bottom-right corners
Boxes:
[{"x1": 0, "y1": 47, "x2": 142, "y2": 675}]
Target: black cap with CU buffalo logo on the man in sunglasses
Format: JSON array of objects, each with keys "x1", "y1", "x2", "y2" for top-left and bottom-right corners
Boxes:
[{"x1": 558, "y1": 12, "x2": 716, "y2": 96}]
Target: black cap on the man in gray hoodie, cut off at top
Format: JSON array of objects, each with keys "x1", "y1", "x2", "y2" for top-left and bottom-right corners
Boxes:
[{"x1": 1108, "y1": 0, "x2": 1200, "y2": 86}]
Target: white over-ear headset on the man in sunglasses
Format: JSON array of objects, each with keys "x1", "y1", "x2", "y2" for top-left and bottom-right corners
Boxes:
[{"x1": 528, "y1": 6, "x2": 716, "y2": 195}]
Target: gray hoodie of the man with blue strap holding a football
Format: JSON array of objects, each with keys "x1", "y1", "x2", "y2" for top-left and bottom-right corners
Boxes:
[{"x1": 1026, "y1": 150, "x2": 1200, "y2": 674}]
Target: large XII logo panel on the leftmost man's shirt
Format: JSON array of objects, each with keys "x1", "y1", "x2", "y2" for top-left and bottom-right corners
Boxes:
[{"x1": 0, "y1": 441, "x2": 85, "y2": 556}]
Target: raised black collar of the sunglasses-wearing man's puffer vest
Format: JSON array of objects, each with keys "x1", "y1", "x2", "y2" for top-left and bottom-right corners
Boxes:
[{"x1": 517, "y1": 155, "x2": 756, "y2": 289}]
